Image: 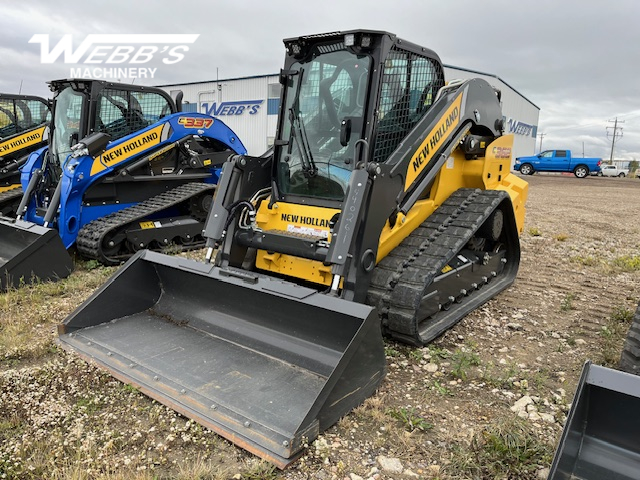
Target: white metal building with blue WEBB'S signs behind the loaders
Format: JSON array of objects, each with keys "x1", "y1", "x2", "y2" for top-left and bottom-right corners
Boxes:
[{"x1": 160, "y1": 65, "x2": 540, "y2": 158}]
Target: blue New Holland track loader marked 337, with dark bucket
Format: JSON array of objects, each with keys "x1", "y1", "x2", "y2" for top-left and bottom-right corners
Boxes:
[{"x1": 0, "y1": 79, "x2": 246, "y2": 289}]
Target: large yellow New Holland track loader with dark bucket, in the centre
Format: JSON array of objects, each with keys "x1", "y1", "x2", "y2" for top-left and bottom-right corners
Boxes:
[{"x1": 59, "y1": 30, "x2": 527, "y2": 467}]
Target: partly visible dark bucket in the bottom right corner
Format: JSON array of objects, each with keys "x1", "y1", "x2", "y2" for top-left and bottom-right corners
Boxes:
[{"x1": 548, "y1": 362, "x2": 640, "y2": 480}]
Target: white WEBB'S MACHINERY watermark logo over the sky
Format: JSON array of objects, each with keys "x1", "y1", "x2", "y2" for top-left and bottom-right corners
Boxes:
[{"x1": 29, "y1": 33, "x2": 200, "y2": 79}]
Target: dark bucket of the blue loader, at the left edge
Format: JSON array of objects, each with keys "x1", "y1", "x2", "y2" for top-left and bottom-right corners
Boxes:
[{"x1": 0, "y1": 219, "x2": 73, "y2": 291}]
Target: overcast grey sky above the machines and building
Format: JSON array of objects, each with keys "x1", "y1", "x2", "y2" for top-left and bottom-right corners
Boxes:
[{"x1": 0, "y1": 0, "x2": 640, "y2": 160}]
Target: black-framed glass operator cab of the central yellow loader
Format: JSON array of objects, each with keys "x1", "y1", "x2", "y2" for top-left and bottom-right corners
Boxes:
[{"x1": 274, "y1": 30, "x2": 444, "y2": 206}]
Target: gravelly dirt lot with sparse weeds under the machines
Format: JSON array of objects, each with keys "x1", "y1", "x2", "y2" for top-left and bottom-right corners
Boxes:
[{"x1": 0, "y1": 175, "x2": 640, "y2": 480}]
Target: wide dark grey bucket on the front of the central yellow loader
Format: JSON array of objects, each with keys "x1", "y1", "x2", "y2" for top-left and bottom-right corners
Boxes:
[{"x1": 59, "y1": 251, "x2": 385, "y2": 468}]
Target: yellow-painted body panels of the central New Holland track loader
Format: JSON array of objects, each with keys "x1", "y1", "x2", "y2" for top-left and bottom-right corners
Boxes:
[{"x1": 256, "y1": 135, "x2": 528, "y2": 285}]
